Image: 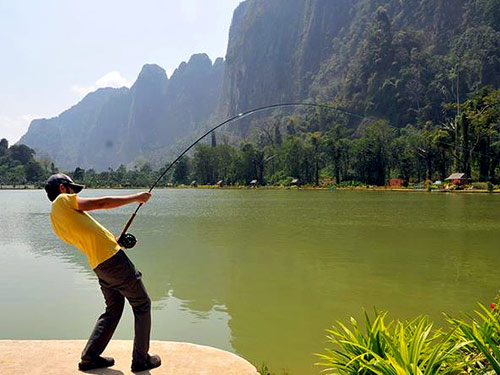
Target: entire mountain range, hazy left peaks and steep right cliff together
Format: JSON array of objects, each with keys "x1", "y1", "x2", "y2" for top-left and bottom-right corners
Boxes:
[{"x1": 20, "y1": 0, "x2": 500, "y2": 169}]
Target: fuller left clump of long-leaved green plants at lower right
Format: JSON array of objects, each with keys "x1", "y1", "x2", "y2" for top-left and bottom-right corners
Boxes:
[{"x1": 318, "y1": 312, "x2": 458, "y2": 375}]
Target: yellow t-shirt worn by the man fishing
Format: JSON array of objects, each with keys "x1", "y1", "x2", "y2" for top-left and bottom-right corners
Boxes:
[{"x1": 50, "y1": 194, "x2": 120, "y2": 269}]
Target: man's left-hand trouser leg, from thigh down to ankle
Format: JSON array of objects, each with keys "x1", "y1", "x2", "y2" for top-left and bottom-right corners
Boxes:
[{"x1": 82, "y1": 285, "x2": 125, "y2": 361}]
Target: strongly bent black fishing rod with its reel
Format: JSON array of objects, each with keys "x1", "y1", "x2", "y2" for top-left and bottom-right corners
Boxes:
[{"x1": 118, "y1": 103, "x2": 366, "y2": 249}]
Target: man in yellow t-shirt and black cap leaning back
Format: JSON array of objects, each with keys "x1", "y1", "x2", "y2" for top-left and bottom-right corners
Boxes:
[{"x1": 45, "y1": 173, "x2": 161, "y2": 372}]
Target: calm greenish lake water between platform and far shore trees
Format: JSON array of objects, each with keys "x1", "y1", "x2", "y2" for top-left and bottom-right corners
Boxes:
[{"x1": 0, "y1": 189, "x2": 500, "y2": 375}]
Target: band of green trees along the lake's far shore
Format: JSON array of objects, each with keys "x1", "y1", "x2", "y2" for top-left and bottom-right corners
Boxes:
[{"x1": 0, "y1": 87, "x2": 500, "y2": 187}]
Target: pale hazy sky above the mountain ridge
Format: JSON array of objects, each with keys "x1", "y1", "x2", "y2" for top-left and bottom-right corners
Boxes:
[{"x1": 0, "y1": 0, "x2": 241, "y2": 144}]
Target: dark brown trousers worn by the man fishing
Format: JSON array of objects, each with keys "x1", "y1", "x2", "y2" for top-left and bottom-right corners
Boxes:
[{"x1": 82, "y1": 250, "x2": 151, "y2": 363}]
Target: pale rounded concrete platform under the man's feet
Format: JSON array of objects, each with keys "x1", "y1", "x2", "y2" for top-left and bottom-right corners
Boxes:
[{"x1": 0, "y1": 340, "x2": 259, "y2": 375}]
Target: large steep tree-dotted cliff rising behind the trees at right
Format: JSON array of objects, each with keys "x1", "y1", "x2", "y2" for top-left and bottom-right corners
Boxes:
[{"x1": 220, "y1": 0, "x2": 500, "y2": 125}]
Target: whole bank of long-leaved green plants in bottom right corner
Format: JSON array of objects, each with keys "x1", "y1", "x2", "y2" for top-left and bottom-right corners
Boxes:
[{"x1": 317, "y1": 297, "x2": 500, "y2": 375}]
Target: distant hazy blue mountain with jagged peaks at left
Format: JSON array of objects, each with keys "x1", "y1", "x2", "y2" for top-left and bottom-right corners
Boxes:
[{"x1": 19, "y1": 54, "x2": 224, "y2": 170}]
